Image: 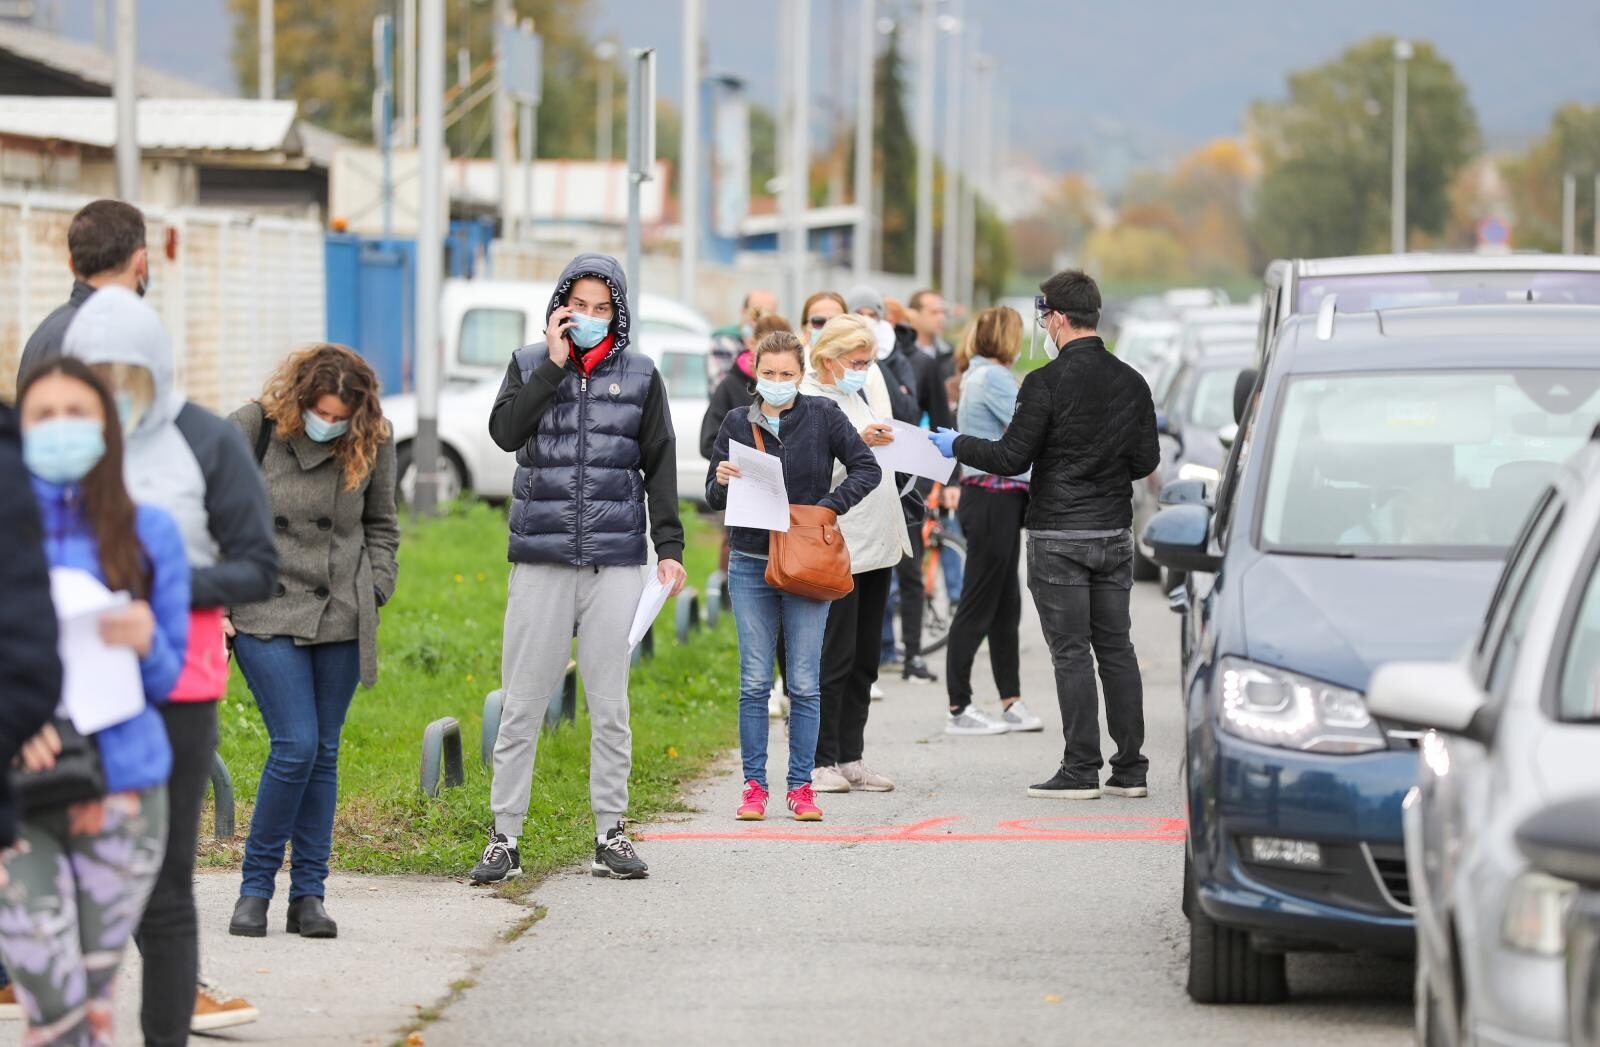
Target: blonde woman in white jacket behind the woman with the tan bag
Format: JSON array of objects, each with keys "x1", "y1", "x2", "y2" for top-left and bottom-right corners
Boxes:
[{"x1": 800, "y1": 315, "x2": 910, "y2": 792}]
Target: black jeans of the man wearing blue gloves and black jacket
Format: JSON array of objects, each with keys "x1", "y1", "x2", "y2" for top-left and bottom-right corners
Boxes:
[{"x1": 1027, "y1": 532, "x2": 1150, "y2": 784}]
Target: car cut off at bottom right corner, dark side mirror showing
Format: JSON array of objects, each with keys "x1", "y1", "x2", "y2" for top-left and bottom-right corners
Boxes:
[{"x1": 1517, "y1": 794, "x2": 1600, "y2": 1047}]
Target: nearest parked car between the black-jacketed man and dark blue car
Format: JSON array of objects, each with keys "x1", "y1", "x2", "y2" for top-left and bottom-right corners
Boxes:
[{"x1": 1133, "y1": 350, "x2": 1254, "y2": 581}]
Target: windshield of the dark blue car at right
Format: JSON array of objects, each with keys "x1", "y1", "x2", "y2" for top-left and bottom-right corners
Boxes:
[{"x1": 1259, "y1": 370, "x2": 1600, "y2": 559}]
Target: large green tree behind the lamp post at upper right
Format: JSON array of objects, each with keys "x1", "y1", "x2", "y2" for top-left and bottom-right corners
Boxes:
[{"x1": 1251, "y1": 37, "x2": 1478, "y2": 256}]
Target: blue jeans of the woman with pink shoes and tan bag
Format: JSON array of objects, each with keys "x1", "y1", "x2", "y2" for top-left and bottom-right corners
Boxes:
[{"x1": 728, "y1": 554, "x2": 827, "y2": 789}]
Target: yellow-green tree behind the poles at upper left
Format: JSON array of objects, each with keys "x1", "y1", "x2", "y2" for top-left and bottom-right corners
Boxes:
[{"x1": 227, "y1": 0, "x2": 608, "y2": 157}]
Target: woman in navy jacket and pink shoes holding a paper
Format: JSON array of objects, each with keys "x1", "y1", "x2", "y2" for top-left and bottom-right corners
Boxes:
[{"x1": 706, "y1": 331, "x2": 883, "y2": 821}]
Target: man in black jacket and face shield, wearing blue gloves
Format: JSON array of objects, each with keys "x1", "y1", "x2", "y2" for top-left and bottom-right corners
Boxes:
[{"x1": 933, "y1": 271, "x2": 1162, "y2": 800}]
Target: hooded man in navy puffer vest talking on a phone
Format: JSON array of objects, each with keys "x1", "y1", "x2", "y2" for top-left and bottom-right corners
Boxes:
[{"x1": 472, "y1": 255, "x2": 683, "y2": 884}]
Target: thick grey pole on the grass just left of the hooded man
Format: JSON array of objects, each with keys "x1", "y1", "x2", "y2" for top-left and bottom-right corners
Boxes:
[{"x1": 411, "y1": 0, "x2": 445, "y2": 517}]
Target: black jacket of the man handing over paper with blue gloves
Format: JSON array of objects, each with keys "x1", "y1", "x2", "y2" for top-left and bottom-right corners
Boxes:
[{"x1": 955, "y1": 338, "x2": 1162, "y2": 532}]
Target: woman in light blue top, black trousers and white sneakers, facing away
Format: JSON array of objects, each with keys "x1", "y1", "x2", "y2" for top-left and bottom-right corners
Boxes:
[{"x1": 944, "y1": 306, "x2": 1045, "y2": 735}]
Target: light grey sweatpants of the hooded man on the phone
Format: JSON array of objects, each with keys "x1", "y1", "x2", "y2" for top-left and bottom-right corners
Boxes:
[{"x1": 490, "y1": 564, "x2": 645, "y2": 836}]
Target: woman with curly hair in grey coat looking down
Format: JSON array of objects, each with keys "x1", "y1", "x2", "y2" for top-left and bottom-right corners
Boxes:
[{"x1": 229, "y1": 344, "x2": 400, "y2": 938}]
